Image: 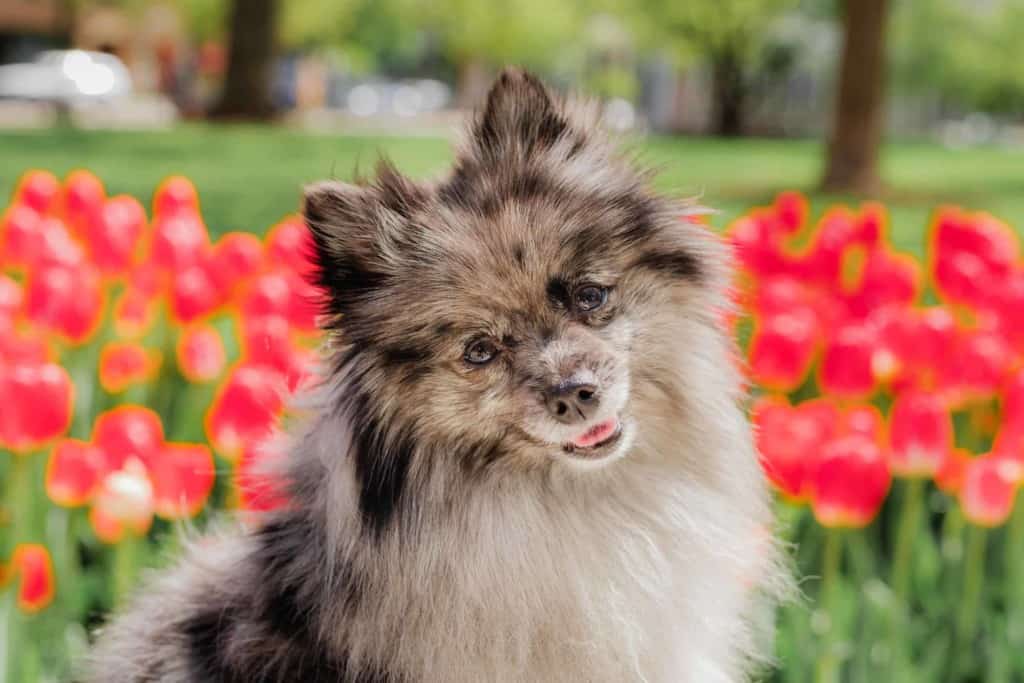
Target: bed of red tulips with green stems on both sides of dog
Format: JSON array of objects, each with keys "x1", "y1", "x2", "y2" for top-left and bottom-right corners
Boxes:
[{"x1": 0, "y1": 171, "x2": 1024, "y2": 681}]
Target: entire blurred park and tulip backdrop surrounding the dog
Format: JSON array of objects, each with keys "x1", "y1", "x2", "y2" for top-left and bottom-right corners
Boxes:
[{"x1": 0, "y1": 0, "x2": 1024, "y2": 683}]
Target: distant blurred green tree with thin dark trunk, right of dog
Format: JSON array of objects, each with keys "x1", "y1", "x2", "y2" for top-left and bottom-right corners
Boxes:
[{"x1": 639, "y1": 0, "x2": 797, "y2": 136}]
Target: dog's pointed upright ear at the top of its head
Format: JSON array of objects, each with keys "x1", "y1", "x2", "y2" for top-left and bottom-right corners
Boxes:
[{"x1": 472, "y1": 69, "x2": 569, "y2": 163}]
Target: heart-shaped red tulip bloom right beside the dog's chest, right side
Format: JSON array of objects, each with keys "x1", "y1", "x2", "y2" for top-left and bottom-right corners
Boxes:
[{"x1": 752, "y1": 396, "x2": 841, "y2": 501}]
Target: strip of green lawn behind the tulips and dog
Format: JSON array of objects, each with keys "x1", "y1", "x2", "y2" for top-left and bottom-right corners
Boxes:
[{"x1": 0, "y1": 125, "x2": 1024, "y2": 253}]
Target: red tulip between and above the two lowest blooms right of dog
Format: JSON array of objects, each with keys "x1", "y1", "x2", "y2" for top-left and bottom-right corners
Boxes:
[{"x1": 889, "y1": 392, "x2": 953, "y2": 477}]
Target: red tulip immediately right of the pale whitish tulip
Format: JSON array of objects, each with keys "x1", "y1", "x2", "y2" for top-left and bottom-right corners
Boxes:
[{"x1": 150, "y1": 443, "x2": 214, "y2": 519}]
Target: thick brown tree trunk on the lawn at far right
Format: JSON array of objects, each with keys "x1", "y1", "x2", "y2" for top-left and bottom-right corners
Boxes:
[{"x1": 822, "y1": 0, "x2": 889, "y2": 194}]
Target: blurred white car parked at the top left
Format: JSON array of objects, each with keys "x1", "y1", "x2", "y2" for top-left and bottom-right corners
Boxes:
[{"x1": 0, "y1": 50, "x2": 132, "y2": 104}]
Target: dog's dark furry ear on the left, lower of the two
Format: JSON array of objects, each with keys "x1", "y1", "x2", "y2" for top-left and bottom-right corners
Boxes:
[{"x1": 302, "y1": 162, "x2": 428, "y2": 313}]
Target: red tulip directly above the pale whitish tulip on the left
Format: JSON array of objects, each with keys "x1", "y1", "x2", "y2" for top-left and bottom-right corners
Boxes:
[{"x1": 92, "y1": 405, "x2": 164, "y2": 471}]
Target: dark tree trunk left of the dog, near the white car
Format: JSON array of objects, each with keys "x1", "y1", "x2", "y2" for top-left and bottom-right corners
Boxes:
[{"x1": 211, "y1": 0, "x2": 278, "y2": 119}]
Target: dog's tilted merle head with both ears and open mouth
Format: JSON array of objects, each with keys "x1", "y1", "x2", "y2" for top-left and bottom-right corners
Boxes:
[{"x1": 305, "y1": 66, "x2": 718, "y2": 479}]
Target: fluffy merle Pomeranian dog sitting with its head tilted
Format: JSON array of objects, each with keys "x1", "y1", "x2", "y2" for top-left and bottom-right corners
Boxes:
[{"x1": 86, "y1": 70, "x2": 786, "y2": 683}]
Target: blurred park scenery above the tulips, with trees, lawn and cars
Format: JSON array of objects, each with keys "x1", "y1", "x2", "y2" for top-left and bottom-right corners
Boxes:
[{"x1": 0, "y1": 0, "x2": 1024, "y2": 240}]
